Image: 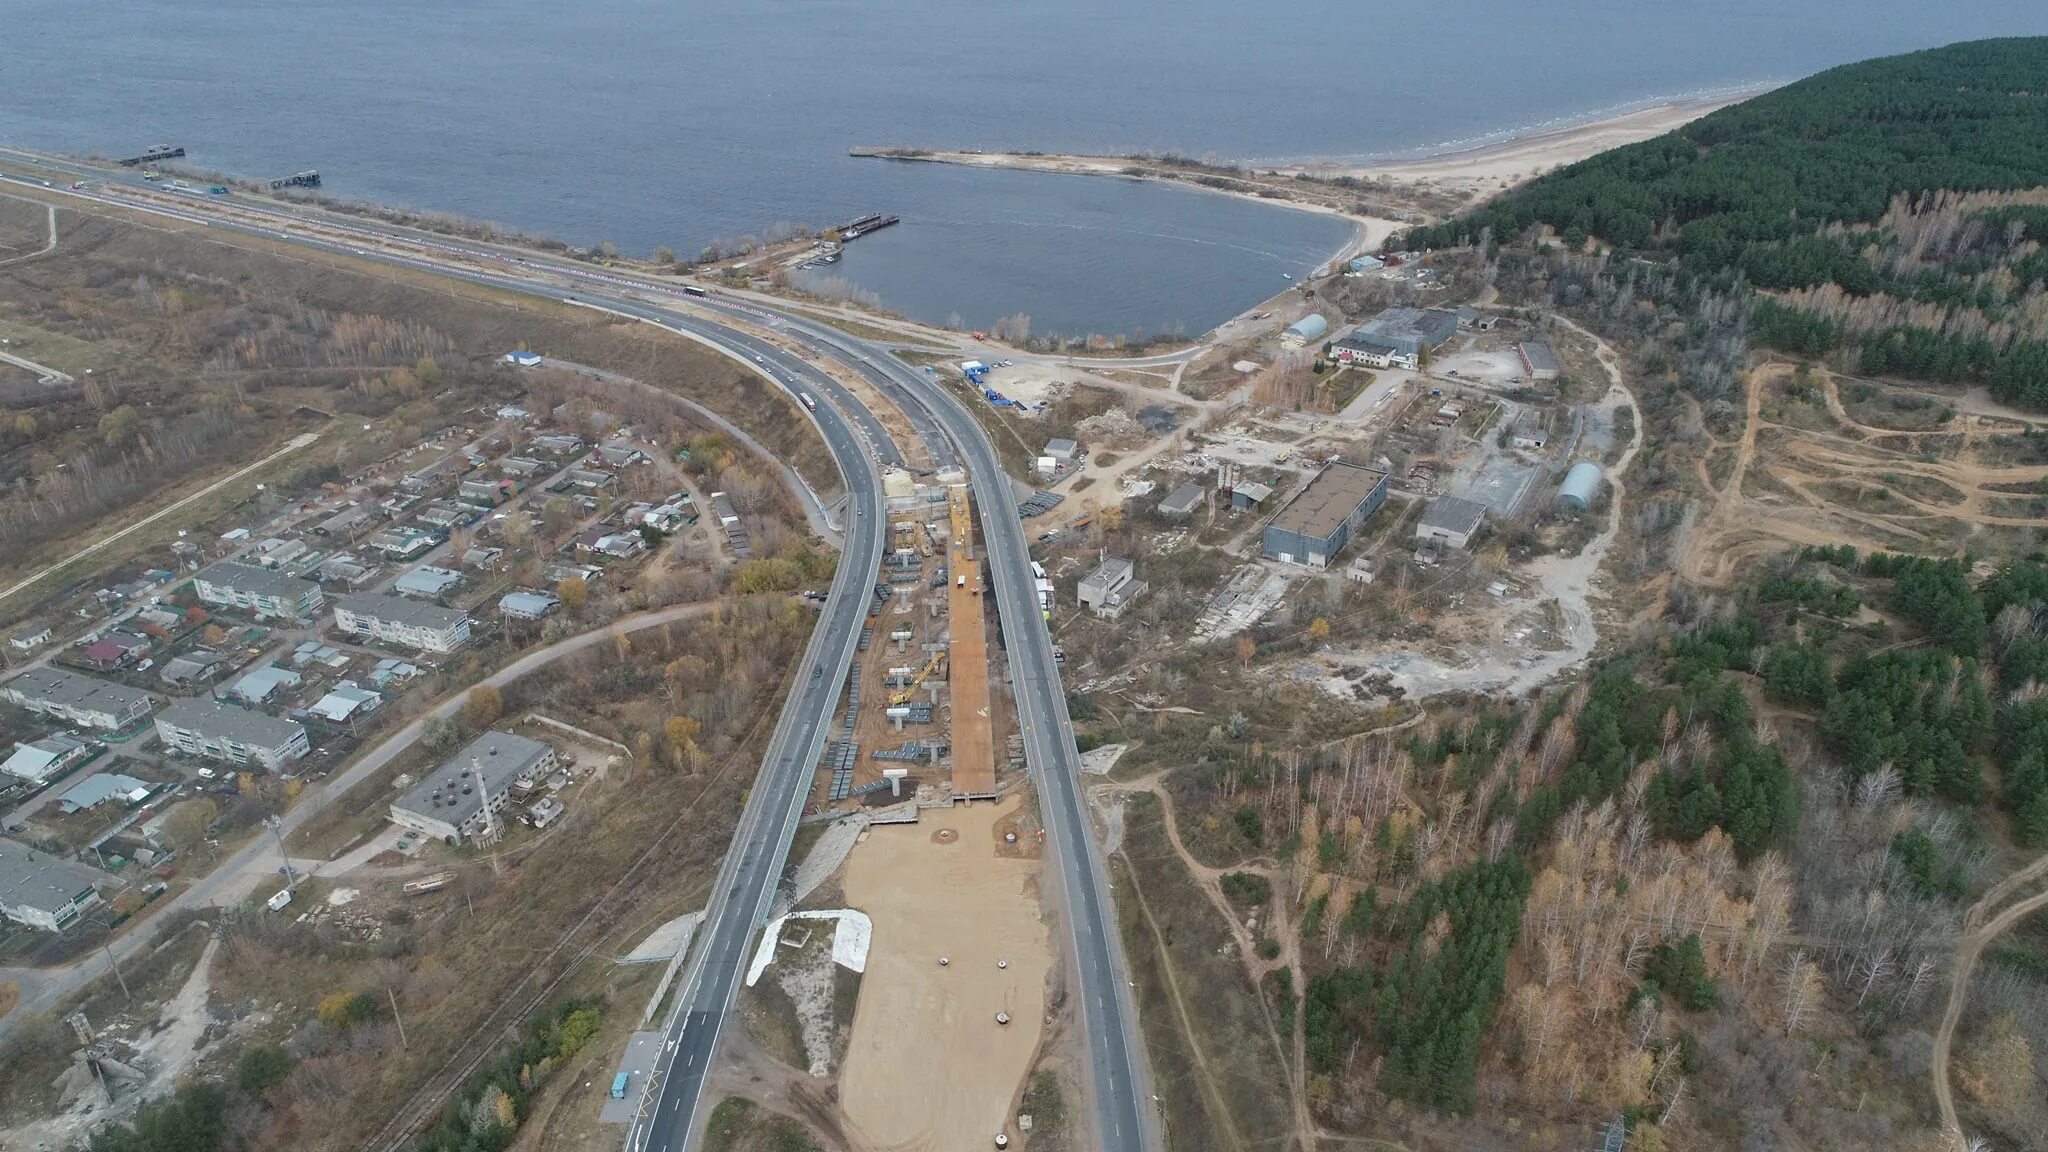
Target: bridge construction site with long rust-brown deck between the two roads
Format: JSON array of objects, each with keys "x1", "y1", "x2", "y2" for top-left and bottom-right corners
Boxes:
[{"x1": 811, "y1": 475, "x2": 1022, "y2": 824}]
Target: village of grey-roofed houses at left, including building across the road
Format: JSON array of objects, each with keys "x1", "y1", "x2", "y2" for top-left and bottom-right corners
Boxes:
[{"x1": 0, "y1": 381, "x2": 750, "y2": 955}]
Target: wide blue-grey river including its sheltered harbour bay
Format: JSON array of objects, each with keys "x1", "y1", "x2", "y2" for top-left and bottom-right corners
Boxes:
[{"x1": 0, "y1": 0, "x2": 2048, "y2": 334}]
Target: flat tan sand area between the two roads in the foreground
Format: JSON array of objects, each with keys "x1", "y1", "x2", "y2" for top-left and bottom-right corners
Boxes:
[{"x1": 840, "y1": 797, "x2": 1053, "y2": 1152}]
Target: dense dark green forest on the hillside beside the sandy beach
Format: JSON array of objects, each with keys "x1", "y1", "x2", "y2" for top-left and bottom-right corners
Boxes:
[{"x1": 1399, "y1": 37, "x2": 2048, "y2": 406}]
